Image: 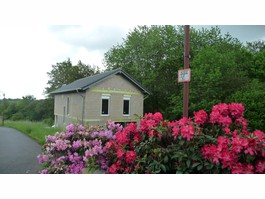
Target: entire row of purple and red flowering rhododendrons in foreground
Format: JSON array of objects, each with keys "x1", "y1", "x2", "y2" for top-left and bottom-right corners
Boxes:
[{"x1": 38, "y1": 103, "x2": 265, "y2": 174}]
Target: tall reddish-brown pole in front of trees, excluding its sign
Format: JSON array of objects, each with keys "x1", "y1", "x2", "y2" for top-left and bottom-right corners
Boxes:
[{"x1": 183, "y1": 25, "x2": 190, "y2": 118}]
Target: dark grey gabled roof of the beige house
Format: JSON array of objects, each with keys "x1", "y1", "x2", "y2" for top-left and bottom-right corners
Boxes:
[{"x1": 50, "y1": 68, "x2": 150, "y2": 95}]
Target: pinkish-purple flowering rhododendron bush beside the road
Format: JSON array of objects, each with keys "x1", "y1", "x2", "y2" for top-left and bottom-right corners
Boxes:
[{"x1": 38, "y1": 122, "x2": 122, "y2": 173}]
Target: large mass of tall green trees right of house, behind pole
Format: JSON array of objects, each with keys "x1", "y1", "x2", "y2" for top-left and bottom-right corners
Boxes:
[{"x1": 105, "y1": 26, "x2": 265, "y2": 130}]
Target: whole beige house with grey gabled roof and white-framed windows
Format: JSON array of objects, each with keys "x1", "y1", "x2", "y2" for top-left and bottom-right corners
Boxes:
[{"x1": 51, "y1": 68, "x2": 150, "y2": 126}]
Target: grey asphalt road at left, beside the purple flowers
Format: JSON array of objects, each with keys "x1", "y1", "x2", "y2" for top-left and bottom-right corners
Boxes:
[{"x1": 0, "y1": 127, "x2": 41, "y2": 174}]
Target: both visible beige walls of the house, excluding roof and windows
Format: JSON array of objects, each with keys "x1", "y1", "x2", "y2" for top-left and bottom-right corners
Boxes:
[{"x1": 54, "y1": 74, "x2": 144, "y2": 126}]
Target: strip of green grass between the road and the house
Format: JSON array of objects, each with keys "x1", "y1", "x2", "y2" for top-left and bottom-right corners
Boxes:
[{"x1": 5, "y1": 121, "x2": 62, "y2": 145}]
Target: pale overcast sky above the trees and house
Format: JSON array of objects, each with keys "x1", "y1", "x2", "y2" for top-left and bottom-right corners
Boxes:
[{"x1": 0, "y1": 25, "x2": 265, "y2": 99}]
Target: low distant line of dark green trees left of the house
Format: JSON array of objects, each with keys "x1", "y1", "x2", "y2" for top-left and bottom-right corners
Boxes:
[{"x1": 0, "y1": 95, "x2": 54, "y2": 125}]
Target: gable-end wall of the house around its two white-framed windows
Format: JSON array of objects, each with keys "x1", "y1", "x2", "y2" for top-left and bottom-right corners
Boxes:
[{"x1": 85, "y1": 75, "x2": 144, "y2": 125}]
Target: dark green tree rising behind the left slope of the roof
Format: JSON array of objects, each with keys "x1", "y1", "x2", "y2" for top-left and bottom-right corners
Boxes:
[{"x1": 45, "y1": 58, "x2": 99, "y2": 94}]
